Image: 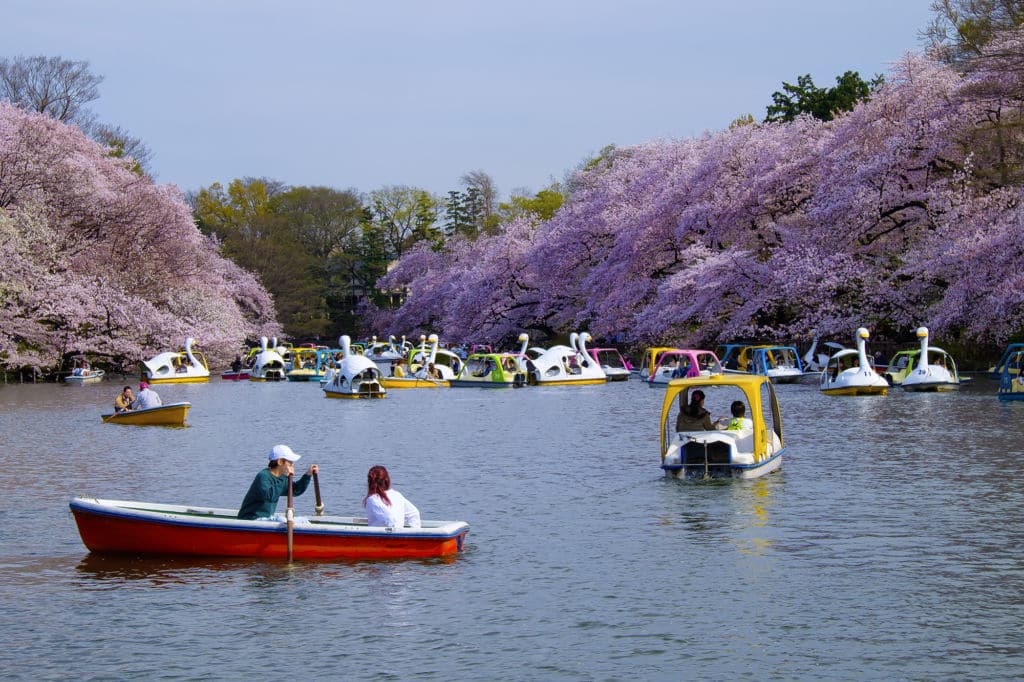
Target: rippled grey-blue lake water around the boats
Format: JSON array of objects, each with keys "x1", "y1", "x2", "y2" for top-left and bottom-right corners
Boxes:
[{"x1": 0, "y1": 377, "x2": 1024, "y2": 680}]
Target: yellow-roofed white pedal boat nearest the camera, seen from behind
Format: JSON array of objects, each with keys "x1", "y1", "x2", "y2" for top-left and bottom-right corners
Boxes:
[{"x1": 662, "y1": 374, "x2": 785, "y2": 479}]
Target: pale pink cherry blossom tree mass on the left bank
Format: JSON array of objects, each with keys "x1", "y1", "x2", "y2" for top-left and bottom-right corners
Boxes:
[{"x1": 0, "y1": 103, "x2": 280, "y2": 370}]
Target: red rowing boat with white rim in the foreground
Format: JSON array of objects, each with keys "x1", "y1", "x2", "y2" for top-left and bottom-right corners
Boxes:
[{"x1": 70, "y1": 498, "x2": 469, "y2": 560}]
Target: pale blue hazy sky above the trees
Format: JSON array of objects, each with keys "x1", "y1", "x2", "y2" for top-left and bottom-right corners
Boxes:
[{"x1": 8, "y1": 0, "x2": 931, "y2": 198}]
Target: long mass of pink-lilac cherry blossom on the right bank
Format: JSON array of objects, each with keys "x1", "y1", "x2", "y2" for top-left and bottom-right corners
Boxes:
[{"x1": 375, "y1": 41, "x2": 1024, "y2": 345}]
